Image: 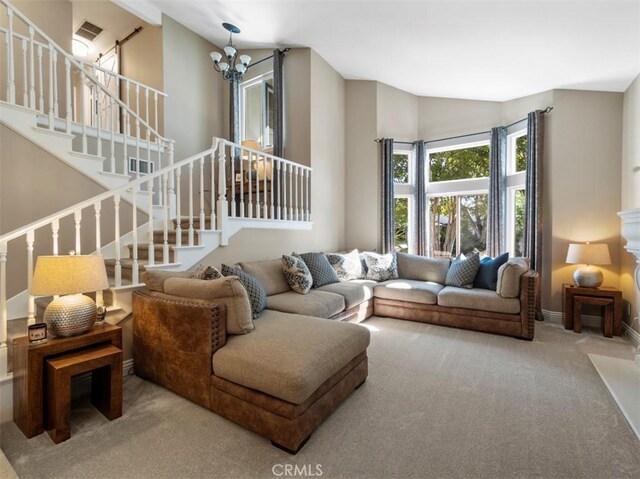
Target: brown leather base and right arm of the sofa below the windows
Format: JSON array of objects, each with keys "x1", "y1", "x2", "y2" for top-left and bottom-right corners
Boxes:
[{"x1": 374, "y1": 271, "x2": 538, "y2": 339}]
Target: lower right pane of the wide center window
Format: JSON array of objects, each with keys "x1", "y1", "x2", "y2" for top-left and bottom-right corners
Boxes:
[{"x1": 459, "y1": 194, "x2": 488, "y2": 255}]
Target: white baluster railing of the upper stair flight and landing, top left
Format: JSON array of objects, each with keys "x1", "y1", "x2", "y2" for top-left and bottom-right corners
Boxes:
[{"x1": 0, "y1": 0, "x2": 173, "y2": 178}]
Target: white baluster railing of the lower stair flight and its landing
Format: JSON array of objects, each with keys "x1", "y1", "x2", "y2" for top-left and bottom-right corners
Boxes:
[{"x1": 0, "y1": 138, "x2": 311, "y2": 376}]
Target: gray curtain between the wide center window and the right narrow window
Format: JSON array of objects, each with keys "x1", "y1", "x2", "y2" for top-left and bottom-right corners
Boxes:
[{"x1": 487, "y1": 127, "x2": 507, "y2": 257}]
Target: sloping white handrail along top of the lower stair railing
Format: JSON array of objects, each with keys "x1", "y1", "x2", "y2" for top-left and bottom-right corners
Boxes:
[{"x1": 0, "y1": 139, "x2": 222, "y2": 243}]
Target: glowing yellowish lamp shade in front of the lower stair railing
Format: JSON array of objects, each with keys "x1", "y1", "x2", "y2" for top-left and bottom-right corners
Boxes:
[{"x1": 31, "y1": 255, "x2": 109, "y2": 296}]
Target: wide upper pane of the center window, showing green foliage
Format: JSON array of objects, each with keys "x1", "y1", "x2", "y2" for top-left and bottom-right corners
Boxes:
[{"x1": 429, "y1": 145, "x2": 489, "y2": 181}]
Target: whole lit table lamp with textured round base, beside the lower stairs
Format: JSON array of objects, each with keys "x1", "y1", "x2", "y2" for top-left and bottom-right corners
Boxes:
[{"x1": 31, "y1": 255, "x2": 109, "y2": 337}]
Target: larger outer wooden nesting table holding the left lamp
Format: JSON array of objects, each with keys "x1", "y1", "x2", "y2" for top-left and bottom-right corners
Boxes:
[{"x1": 13, "y1": 324, "x2": 122, "y2": 438}]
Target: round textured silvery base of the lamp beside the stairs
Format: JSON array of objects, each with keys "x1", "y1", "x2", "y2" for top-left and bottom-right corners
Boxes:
[{"x1": 44, "y1": 294, "x2": 96, "y2": 337}]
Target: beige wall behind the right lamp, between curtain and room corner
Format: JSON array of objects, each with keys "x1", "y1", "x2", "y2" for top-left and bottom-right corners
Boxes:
[{"x1": 542, "y1": 90, "x2": 623, "y2": 311}]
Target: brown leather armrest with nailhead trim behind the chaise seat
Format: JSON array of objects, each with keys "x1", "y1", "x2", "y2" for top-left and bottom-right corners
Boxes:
[{"x1": 133, "y1": 290, "x2": 226, "y2": 407}]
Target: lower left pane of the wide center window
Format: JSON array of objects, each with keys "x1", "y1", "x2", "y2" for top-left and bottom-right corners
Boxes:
[{"x1": 428, "y1": 196, "x2": 458, "y2": 258}]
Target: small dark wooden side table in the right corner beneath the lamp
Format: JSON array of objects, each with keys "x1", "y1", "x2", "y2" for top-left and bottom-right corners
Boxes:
[{"x1": 562, "y1": 284, "x2": 622, "y2": 338}]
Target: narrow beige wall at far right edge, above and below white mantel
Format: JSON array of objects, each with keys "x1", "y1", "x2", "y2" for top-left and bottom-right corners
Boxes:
[{"x1": 620, "y1": 75, "x2": 640, "y2": 333}]
